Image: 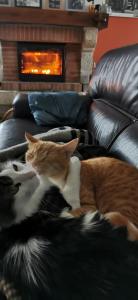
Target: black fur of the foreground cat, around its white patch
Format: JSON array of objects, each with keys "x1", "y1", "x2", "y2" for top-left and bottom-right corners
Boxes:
[{"x1": 0, "y1": 212, "x2": 138, "y2": 300}]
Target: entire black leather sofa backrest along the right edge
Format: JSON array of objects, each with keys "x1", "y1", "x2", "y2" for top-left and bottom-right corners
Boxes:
[{"x1": 89, "y1": 44, "x2": 138, "y2": 166}]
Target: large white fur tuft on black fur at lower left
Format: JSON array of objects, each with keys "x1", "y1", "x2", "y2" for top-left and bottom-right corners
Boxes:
[{"x1": 5, "y1": 238, "x2": 50, "y2": 285}]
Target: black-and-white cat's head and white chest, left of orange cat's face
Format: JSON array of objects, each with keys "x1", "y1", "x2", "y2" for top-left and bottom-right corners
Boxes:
[{"x1": 0, "y1": 161, "x2": 70, "y2": 226}]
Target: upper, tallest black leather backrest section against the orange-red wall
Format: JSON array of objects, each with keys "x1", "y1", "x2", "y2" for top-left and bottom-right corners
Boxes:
[{"x1": 89, "y1": 44, "x2": 138, "y2": 119}]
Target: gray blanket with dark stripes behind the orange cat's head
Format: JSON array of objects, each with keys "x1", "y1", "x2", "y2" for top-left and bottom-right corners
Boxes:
[{"x1": 0, "y1": 126, "x2": 93, "y2": 161}]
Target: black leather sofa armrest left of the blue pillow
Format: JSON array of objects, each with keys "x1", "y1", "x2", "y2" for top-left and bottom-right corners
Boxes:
[{"x1": 12, "y1": 93, "x2": 34, "y2": 119}]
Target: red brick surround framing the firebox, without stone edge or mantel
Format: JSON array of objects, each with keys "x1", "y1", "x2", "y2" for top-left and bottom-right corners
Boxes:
[{"x1": 0, "y1": 24, "x2": 82, "y2": 91}]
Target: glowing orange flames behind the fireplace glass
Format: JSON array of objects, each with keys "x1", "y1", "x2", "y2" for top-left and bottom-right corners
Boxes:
[{"x1": 21, "y1": 50, "x2": 62, "y2": 75}]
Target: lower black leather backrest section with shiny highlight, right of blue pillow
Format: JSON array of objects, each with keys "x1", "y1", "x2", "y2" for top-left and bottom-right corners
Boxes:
[{"x1": 88, "y1": 99, "x2": 133, "y2": 149}]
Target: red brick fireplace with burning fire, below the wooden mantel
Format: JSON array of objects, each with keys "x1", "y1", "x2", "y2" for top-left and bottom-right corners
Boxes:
[{"x1": 0, "y1": 22, "x2": 97, "y2": 92}]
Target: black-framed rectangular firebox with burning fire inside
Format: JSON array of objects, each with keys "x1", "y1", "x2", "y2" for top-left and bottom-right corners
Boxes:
[{"x1": 18, "y1": 42, "x2": 65, "y2": 82}]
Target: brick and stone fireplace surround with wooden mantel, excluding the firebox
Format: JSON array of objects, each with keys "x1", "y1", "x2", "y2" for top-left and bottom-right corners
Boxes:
[{"x1": 0, "y1": 7, "x2": 107, "y2": 113}]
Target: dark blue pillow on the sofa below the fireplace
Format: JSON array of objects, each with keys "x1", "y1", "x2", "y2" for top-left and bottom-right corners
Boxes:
[{"x1": 28, "y1": 92, "x2": 90, "y2": 128}]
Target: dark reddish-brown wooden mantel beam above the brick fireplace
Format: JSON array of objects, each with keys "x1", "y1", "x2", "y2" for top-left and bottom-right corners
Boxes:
[{"x1": 0, "y1": 7, "x2": 108, "y2": 28}]
